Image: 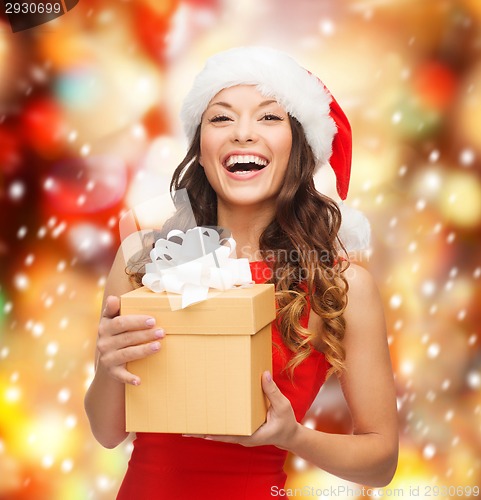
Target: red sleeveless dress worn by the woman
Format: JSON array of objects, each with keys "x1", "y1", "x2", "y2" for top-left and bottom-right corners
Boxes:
[{"x1": 117, "y1": 262, "x2": 329, "y2": 500}]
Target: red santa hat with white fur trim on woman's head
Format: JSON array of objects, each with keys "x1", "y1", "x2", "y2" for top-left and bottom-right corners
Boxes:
[{"x1": 180, "y1": 47, "x2": 369, "y2": 254}]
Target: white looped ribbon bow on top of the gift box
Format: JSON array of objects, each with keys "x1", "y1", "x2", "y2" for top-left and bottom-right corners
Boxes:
[{"x1": 142, "y1": 227, "x2": 253, "y2": 309}]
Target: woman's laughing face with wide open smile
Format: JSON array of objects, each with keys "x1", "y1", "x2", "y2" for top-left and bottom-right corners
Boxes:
[{"x1": 199, "y1": 85, "x2": 292, "y2": 207}]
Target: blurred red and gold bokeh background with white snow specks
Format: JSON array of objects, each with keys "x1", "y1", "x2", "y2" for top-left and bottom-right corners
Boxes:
[{"x1": 0, "y1": 0, "x2": 481, "y2": 500}]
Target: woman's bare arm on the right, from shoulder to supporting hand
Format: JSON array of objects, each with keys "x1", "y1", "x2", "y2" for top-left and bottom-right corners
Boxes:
[{"x1": 204, "y1": 265, "x2": 398, "y2": 487}]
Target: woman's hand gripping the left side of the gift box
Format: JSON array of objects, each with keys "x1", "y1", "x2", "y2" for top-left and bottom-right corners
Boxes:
[{"x1": 97, "y1": 295, "x2": 165, "y2": 385}]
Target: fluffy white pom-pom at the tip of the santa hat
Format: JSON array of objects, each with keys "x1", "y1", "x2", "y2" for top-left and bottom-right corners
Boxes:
[{"x1": 339, "y1": 203, "x2": 371, "y2": 256}]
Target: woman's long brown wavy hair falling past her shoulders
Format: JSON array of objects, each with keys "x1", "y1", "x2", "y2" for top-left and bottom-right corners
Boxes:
[{"x1": 126, "y1": 115, "x2": 349, "y2": 374}]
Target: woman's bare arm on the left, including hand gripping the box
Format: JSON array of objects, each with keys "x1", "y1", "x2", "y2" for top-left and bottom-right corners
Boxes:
[{"x1": 85, "y1": 251, "x2": 164, "y2": 448}]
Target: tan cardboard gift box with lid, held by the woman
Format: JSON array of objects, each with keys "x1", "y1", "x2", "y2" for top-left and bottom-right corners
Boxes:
[{"x1": 121, "y1": 284, "x2": 275, "y2": 435}]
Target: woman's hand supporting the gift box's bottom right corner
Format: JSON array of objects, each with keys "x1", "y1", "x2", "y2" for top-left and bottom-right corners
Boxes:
[{"x1": 184, "y1": 372, "x2": 300, "y2": 450}]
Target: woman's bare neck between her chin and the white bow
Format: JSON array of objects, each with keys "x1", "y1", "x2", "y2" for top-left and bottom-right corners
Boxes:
[{"x1": 217, "y1": 200, "x2": 273, "y2": 261}]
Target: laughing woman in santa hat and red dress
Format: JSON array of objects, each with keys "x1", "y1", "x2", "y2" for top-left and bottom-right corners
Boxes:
[{"x1": 85, "y1": 47, "x2": 398, "y2": 500}]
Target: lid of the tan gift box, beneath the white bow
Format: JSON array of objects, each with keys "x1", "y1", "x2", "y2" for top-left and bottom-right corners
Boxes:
[{"x1": 120, "y1": 284, "x2": 276, "y2": 335}]
